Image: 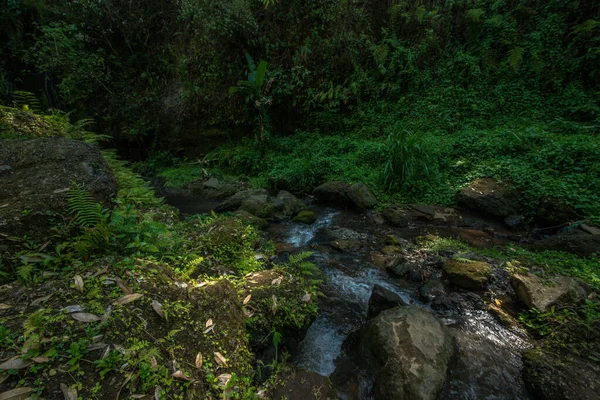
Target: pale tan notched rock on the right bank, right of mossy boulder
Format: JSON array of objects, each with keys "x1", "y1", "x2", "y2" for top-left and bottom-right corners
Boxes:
[{"x1": 510, "y1": 274, "x2": 586, "y2": 311}]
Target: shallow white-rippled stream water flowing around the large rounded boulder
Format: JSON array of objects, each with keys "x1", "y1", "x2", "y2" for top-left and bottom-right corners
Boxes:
[{"x1": 272, "y1": 209, "x2": 529, "y2": 400}]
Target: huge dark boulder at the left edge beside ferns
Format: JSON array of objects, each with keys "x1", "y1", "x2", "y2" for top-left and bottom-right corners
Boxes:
[{"x1": 0, "y1": 138, "x2": 118, "y2": 239}]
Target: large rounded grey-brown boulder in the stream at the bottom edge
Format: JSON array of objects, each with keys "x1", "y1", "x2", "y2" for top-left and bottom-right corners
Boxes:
[{"x1": 359, "y1": 307, "x2": 453, "y2": 400}]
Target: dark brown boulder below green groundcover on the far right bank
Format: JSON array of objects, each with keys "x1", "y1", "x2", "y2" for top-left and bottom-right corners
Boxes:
[{"x1": 456, "y1": 178, "x2": 519, "y2": 218}]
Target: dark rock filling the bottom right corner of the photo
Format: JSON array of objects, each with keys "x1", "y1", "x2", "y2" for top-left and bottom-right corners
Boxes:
[{"x1": 523, "y1": 349, "x2": 600, "y2": 400}]
